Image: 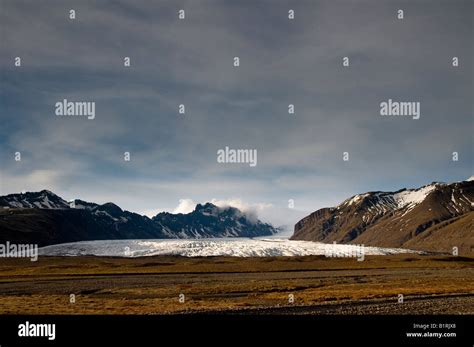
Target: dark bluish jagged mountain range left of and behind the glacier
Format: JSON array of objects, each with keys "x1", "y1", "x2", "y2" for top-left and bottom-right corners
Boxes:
[{"x1": 0, "y1": 190, "x2": 278, "y2": 246}]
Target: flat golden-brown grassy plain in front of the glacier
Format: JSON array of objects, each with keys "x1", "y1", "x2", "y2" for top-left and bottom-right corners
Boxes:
[{"x1": 0, "y1": 255, "x2": 474, "y2": 314}]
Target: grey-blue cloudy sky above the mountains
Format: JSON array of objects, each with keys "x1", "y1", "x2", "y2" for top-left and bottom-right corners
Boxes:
[{"x1": 0, "y1": 0, "x2": 474, "y2": 231}]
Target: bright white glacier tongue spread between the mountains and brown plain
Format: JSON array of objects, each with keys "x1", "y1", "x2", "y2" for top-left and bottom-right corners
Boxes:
[{"x1": 38, "y1": 238, "x2": 419, "y2": 257}]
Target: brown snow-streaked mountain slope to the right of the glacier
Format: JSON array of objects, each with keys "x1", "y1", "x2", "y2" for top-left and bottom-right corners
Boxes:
[{"x1": 292, "y1": 179, "x2": 474, "y2": 252}]
